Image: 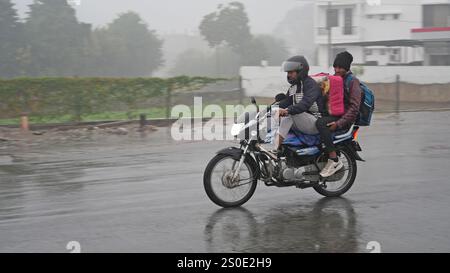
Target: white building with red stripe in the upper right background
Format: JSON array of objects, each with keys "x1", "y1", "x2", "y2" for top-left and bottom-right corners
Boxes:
[{"x1": 315, "y1": 0, "x2": 450, "y2": 66}]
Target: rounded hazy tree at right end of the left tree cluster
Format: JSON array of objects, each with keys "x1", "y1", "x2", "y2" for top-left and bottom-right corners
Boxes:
[{"x1": 90, "y1": 12, "x2": 163, "y2": 77}]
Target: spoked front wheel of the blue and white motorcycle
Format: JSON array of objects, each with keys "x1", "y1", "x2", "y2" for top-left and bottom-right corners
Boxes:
[{"x1": 203, "y1": 154, "x2": 258, "y2": 208}]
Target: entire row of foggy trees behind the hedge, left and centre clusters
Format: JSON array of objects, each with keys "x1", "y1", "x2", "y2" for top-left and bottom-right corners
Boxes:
[{"x1": 0, "y1": 0, "x2": 289, "y2": 78}]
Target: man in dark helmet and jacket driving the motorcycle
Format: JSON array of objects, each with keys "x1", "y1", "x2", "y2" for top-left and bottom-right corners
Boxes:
[{"x1": 275, "y1": 56, "x2": 324, "y2": 152}]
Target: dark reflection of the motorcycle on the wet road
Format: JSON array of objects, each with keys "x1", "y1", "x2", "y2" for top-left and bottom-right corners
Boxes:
[{"x1": 205, "y1": 198, "x2": 358, "y2": 252}]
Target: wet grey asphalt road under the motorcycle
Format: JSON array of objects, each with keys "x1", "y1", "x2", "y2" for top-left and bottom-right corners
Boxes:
[{"x1": 0, "y1": 112, "x2": 450, "y2": 252}]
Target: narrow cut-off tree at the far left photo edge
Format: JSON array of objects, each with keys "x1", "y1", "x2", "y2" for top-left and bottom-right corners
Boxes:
[{"x1": 0, "y1": 0, "x2": 22, "y2": 78}]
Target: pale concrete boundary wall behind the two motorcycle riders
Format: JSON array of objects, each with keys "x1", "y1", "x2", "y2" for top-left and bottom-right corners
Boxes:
[{"x1": 240, "y1": 66, "x2": 450, "y2": 102}]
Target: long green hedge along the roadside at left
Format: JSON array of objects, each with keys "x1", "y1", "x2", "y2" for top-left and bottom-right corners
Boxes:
[{"x1": 0, "y1": 76, "x2": 225, "y2": 121}]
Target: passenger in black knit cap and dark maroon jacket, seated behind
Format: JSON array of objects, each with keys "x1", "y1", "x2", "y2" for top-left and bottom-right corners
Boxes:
[{"x1": 316, "y1": 51, "x2": 362, "y2": 178}]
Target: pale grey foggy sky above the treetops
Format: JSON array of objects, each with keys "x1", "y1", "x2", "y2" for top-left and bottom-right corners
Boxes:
[{"x1": 13, "y1": 0, "x2": 302, "y2": 35}]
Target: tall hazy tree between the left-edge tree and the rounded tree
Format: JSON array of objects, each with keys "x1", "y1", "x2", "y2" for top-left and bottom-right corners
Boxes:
[{"x1": 25, "y1": 0, "x2": 91, "y2": 76}]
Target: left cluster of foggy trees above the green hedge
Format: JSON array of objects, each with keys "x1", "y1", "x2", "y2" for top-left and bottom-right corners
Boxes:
[{"x1": 0, "y1": 0, "x2": 163, "y2": 78}]
